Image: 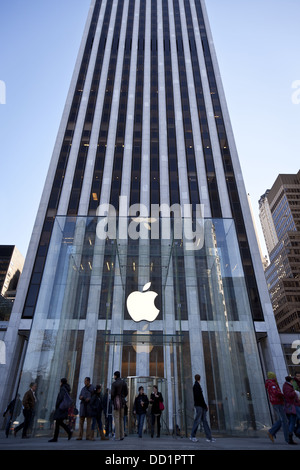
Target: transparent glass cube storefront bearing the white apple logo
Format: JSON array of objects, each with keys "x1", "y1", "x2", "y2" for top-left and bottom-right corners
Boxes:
[{"x1": 14, "y1": 217, "x2": 270, "y2": 435}]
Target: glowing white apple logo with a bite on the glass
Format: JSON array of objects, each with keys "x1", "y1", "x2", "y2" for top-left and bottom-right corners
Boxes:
[{"x1": 127, "y1": 282, "x2": 159, "y2": 322}]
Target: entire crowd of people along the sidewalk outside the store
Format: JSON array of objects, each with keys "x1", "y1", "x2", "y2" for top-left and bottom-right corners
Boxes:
[{"x1": 3, "y1": 371, "x2": 300, "y2": 445}]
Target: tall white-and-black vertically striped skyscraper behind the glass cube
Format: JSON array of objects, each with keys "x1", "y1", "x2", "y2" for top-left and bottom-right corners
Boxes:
[{"x1": 0, "y1": 0, "x2": 286, "y2": 433}]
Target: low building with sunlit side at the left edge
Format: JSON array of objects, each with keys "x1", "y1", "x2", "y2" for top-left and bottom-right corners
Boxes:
[{"x1": 0, "y1": 245, "x2": 24, "y2": 321}]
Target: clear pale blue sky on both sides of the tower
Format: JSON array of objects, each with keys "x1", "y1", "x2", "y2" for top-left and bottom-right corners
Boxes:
[{"x1": 0, "y1": 0, "x2": 300, "y2": 256}]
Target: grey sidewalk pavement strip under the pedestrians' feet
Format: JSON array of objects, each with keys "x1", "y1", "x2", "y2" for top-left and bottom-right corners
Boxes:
[{"x1": 0, "y1": 431, "x2": 300, "y2": 455}]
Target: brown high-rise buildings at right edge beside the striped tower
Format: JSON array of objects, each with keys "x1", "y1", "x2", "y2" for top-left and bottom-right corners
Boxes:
[{"x1": 260, "y1": 171, "x2": 300, "y2": 333}]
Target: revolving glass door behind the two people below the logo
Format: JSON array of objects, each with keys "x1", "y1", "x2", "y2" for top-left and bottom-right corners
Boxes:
[{"x1": 126, "y1": 376, "x2": 169, "y2": 435}]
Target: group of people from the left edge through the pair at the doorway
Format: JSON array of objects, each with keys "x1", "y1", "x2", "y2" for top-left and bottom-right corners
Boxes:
[{"x1": 3, "y1": 371, "x2": 163, "y2": 442}]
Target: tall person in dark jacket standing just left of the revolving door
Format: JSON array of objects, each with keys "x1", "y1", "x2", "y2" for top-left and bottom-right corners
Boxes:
[{"x1": 111, "y1": 371, "x2": 128, "y2": 441}]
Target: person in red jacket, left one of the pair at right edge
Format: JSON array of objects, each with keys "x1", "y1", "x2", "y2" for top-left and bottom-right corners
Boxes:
[{"x1": 265, "y1": 372, "x2": 289, "y2": 443}]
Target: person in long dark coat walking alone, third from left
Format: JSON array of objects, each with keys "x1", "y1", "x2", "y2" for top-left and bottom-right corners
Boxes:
[{"x1": 48, "y1": 378, "x2": 73, "y2": 442}]
